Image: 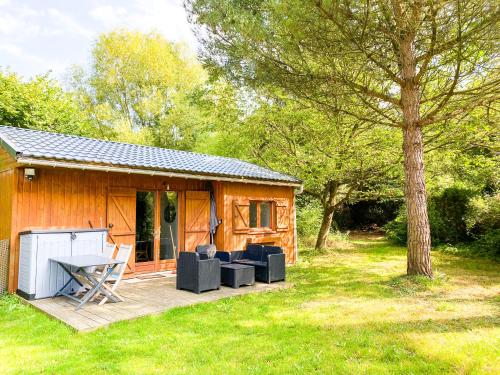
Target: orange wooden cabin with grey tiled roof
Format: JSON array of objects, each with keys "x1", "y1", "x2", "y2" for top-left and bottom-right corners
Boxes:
[{"x1": 0, "y1": 126, "x2": 301, "y2": 292}]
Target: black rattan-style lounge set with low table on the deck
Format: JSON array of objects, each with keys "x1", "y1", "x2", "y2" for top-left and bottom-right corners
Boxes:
[{"x1": 177, "y1": 244, "x2": 285, "y2": 293}]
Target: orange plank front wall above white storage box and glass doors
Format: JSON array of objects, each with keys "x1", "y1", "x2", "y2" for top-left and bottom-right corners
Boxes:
[{"x1": 6, "y1": 168, "x2": 206, "y2": 292}]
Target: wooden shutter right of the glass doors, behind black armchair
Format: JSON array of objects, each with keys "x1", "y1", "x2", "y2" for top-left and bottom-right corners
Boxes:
[{"x1": 184, "y1": 191, "x2": 210, "y2": 251}]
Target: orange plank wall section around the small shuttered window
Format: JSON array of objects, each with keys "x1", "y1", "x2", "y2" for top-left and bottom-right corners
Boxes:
[{"x1": 220, "y1": 182, "x2": 296, "y2": 263}]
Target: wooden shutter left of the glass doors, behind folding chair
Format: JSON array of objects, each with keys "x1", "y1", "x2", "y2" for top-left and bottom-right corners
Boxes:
[{"x1": 107, "y1": 188, "x2": 136, "y2": 273}]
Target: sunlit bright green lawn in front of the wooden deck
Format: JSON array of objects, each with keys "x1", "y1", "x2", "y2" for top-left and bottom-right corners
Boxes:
[{"x1": 0, "y1": 235, "x2": 500, "y2": 374}]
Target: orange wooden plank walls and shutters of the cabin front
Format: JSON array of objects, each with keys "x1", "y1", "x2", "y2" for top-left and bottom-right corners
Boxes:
[{"x1": 5, "y1": 165, "x2": 295, "y2": 292}]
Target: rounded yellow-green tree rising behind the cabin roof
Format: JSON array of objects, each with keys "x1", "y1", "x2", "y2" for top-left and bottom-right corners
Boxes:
[{"x1": 69, "y1": 30, "x2": 206, "y2": 149}]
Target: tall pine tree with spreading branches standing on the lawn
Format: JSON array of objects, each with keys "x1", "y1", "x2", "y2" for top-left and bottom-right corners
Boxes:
[{"x1": 186, "y1": 0, "x2": 499, "y2": 276}]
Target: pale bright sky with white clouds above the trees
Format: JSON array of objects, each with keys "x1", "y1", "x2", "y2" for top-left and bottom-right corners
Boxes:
[{"x1": 0, "y1": 0, "x2": 197, "y2": 79}]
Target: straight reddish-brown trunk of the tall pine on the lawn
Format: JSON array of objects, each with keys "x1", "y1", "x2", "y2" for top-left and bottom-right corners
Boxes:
[{"x1": 400, "y1": 26, "x2": 432, "y2": 277}]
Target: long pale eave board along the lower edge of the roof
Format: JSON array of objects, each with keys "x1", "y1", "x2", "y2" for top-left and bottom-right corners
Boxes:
[{"x1": 16, "y1": 155, "x2": 302, "y2": 189}]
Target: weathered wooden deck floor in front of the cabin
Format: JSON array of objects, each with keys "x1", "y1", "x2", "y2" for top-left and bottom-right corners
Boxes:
[{"x1": 29, "y1": 276, "x2": 286, "y2": 331}]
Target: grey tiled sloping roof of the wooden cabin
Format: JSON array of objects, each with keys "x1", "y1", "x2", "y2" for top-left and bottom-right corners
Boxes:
[{"x1": 0, "y1": 126, "x2": 301, "y2": 185}]
